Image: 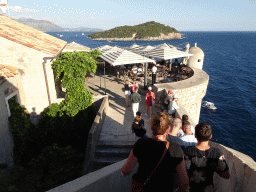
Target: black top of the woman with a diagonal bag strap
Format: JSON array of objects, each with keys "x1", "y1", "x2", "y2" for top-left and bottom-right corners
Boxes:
[{"x1": 133, "y1": 138, "x2": 184, "y2": 191}]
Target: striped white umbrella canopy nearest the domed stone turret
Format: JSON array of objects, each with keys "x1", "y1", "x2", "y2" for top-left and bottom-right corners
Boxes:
[{"x1": 147, "y1": 43, "x2": 193, "y2": 60}]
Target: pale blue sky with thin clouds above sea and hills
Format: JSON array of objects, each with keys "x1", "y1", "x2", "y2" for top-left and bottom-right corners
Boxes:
[{"x1": 0, "y1": 0, "x2": 256, "y2": 31}]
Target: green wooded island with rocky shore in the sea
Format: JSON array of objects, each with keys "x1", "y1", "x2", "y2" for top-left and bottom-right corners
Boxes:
[{"x1": 88, "y1": 21, "x2": 181, "y2": 40}]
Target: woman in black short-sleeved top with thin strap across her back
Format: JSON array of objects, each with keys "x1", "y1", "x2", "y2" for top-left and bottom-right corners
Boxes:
[{"x1": 121, "y1": 113, "x2": 189, "y2": 192}]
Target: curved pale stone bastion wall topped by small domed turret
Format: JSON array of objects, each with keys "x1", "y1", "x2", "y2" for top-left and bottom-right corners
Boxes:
[{"x1": 154, "y1": 43, "x2": 209, "y2": 125}]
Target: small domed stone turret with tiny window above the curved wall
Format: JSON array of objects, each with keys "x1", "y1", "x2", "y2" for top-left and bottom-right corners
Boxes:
[{"x1": 188, "y1": 43, "x2": 204, "y2": 70}]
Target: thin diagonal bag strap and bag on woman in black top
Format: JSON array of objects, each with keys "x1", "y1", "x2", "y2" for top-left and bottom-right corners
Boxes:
[{"x1": 131, "y1": 141, "x2": 170, "y2": 192}]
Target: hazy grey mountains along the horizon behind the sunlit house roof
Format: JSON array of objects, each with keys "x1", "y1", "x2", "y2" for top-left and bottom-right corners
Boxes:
[{"x1": 15, "y1": 18, "x2": 103, "y2": 31}]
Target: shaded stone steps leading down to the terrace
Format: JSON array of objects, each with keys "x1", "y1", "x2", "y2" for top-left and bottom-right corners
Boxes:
[{"x1": 91, "y1": 141, "x2": 135, "y2": 172}]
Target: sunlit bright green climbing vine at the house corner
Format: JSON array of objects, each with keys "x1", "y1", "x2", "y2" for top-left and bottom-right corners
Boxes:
[{"x1": 52, "y1": 50, "x2": 101, "y2": 117}]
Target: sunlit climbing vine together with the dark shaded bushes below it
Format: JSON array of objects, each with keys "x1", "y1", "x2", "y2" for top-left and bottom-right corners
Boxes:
[{"x1": 6, "y1": 50, "x2": 100, "y2": 191}]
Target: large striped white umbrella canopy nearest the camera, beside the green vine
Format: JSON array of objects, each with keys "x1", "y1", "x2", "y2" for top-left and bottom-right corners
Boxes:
[{"x1": 99, "y1": 50, "x2": 155, "y2": 66}]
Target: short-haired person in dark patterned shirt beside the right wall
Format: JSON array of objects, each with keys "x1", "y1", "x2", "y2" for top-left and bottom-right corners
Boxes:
[{"x1": 185, "y1": 123, "x2": 230, "y2": 192}]
